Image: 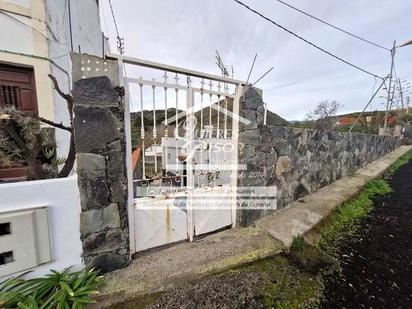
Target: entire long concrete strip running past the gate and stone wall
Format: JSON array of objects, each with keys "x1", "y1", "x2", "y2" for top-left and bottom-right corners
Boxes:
[{"x1": 93, "y1": 146, "x2": 412, "y2": 308}]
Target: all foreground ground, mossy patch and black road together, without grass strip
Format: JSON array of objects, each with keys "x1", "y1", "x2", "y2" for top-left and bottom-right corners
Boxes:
[{"x1": 116, "y1": 161, "x2": 412, "y2": 309}]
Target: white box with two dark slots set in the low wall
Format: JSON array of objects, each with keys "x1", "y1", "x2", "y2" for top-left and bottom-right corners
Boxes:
[{"x1": 0, "y1": 207, "x2": 51, "y2": 277}]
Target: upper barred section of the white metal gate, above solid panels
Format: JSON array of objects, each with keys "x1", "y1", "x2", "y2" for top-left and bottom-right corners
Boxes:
[{"x1": 107, "y1": 54, "x2": 244, "y2": 197}]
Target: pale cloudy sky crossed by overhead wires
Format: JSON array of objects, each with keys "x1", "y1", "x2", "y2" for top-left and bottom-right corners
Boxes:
[{"x1": 100, "y1": 0, "x2": 412, "y2": 120}]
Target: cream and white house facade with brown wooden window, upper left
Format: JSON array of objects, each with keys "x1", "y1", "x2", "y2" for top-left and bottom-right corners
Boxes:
[{"x1": 0, "y1": 0, "x2": 108, "y2": 177}]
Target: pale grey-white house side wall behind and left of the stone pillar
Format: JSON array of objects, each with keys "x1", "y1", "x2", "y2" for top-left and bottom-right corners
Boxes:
[{"x1": 46, "y1": 0, "x2": 103, "y2": 157}]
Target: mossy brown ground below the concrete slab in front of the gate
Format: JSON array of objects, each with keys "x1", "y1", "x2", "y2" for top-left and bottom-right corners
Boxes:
[{"x1": 113, "y1": 255, "x2": 319, "y2": 309}]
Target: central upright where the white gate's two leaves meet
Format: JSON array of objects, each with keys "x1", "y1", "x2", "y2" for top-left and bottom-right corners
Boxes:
[{"x1": 186, "y1": 76, "x2": 195, "y2": 241}]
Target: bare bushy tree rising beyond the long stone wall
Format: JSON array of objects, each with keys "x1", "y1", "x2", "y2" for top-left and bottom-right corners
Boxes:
[{"x1": 305, "y1": 100, "x2": 343, "y2": 130}]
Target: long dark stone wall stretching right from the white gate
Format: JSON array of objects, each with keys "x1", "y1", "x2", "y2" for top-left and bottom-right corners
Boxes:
[{"x1": 237, "y1": 88, "x2": 400, "y2": 225}]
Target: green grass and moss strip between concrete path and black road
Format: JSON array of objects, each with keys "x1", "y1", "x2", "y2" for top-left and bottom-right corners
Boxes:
[{"x1": 246, "y1": 158, "x2": 404, "y2": 308}]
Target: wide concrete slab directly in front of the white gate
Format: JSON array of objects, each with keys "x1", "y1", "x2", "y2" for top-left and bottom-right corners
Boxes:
[{"x1": 93, "y1": 227, "x2": 284, "y2": 308}]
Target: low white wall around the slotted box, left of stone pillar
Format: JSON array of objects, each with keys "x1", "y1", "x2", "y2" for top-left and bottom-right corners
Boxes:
[{"x1": 0, "y1": 176, "x2": 82, "y2": 277}]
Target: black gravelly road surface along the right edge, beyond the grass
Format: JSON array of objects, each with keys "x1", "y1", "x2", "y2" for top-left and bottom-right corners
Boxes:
[{"x1": 322, "y1": 161, "x2": 412, "y2": 308}]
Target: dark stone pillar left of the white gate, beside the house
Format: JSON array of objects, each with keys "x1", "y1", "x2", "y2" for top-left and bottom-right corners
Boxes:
[{"x1": 72, "y1": 55, "x2": 130, "y2": 273}]
